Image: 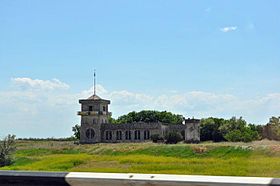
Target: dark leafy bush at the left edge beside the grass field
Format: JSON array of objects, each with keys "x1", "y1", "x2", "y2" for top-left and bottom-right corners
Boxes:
[{"x1": 0, "y1": 134, "x2": 16, "y2": 167}]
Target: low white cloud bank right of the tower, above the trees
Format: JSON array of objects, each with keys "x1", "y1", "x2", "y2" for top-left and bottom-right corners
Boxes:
[{"x1": 96, "y1": 88, "x2": 280, "y2": 124}]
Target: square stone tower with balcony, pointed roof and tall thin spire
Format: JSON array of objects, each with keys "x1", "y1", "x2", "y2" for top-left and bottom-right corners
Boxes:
[{"x1": 78, "y1": 70, "x2": 111, "y2": 143}]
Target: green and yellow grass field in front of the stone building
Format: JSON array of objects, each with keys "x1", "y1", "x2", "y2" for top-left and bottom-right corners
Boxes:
[{"x1": 0, "y1": 141, "x2": 280, "y2": 177}]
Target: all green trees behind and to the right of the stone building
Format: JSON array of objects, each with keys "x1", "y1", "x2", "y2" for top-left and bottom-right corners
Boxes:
[{"x1": 110, "y1": 110, "x2": 280, "y2": 142}]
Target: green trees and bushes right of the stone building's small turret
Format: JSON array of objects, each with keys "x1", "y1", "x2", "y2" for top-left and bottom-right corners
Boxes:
[{"x1": 200, "y1": 116, "x2": 280, "y2": 142}]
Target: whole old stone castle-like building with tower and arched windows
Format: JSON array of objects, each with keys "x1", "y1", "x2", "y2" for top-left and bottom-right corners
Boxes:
[{"x1": 78, "y1": 93, "x2": 200, "y2": 143}]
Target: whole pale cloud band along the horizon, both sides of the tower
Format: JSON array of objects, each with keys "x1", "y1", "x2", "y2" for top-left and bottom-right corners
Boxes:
[{"x1": 0, "y1": 78, "x2": 280, "y2": 137}]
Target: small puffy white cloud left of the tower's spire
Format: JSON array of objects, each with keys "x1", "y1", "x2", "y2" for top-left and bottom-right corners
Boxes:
[{"x1": 12, "y1": 77, "x2": 69, "y2": 90}]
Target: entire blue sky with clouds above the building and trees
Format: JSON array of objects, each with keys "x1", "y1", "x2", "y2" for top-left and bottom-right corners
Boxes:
[{"x1": 0, "y1": 0, "x2": 280, "y2": 137}]
